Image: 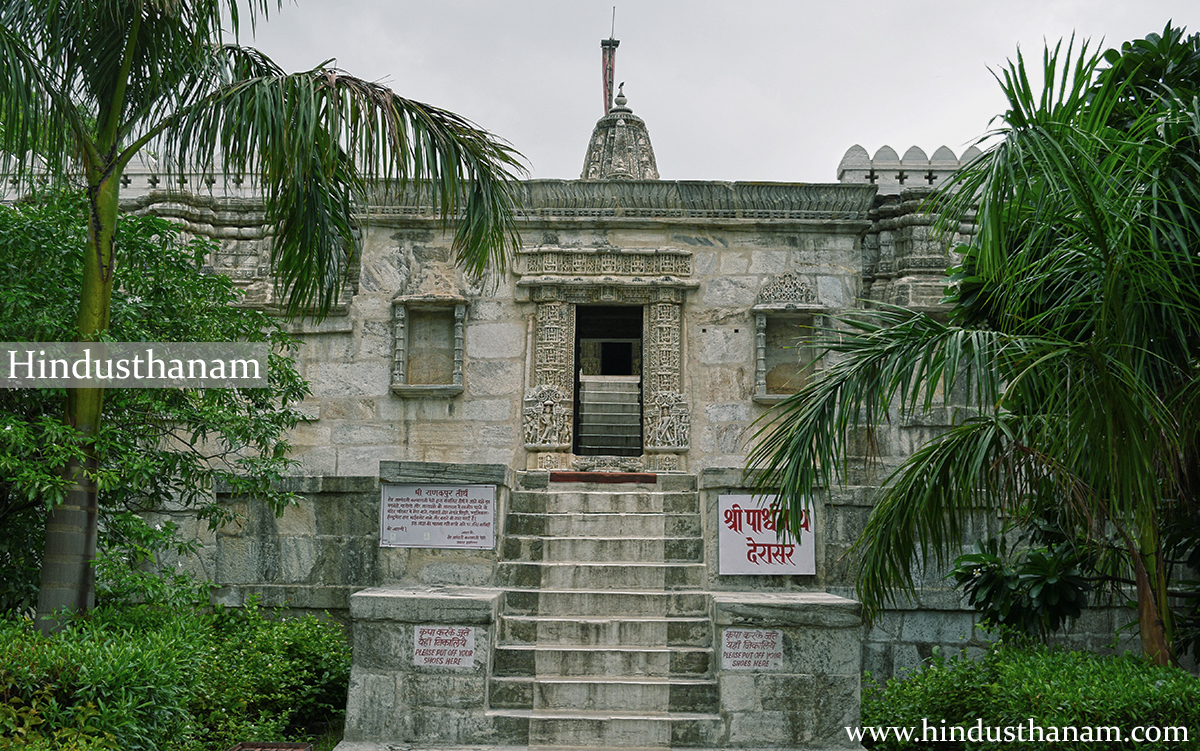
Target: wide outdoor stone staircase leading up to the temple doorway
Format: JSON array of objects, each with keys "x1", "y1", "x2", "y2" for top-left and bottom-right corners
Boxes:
[{"x1": 488, "y1": 477, "x2": 721, "y2": 749}]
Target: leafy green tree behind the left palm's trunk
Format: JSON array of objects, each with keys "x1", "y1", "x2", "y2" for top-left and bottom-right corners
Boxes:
[{"x1": 0, "y1": 193, "x2": 307, "y2": 613}]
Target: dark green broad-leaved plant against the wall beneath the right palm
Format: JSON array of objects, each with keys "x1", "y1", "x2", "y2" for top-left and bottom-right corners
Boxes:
[{"x1": 950, "y1": 536, "x2": 1091, "y2": 637}]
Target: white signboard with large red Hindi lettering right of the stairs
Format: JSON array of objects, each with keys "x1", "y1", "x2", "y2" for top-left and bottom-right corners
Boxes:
[{"x1": 716, "y1": 495, "x2": 817, "y2": 575}]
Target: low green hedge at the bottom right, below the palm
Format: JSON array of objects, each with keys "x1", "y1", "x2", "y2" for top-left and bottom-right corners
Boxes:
[{"x1": 862, "y1": 639, "x2": 1200, "y2": 751}]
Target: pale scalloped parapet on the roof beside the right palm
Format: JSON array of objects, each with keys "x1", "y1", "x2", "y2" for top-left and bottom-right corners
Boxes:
[{"x1": 838, "y1": 144, "x2": 980, "y2": 196}]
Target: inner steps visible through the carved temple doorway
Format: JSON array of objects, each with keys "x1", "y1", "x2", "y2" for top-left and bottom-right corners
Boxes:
[{"x1": 576, "y1": 376, "x2": 642, "y2": 456}]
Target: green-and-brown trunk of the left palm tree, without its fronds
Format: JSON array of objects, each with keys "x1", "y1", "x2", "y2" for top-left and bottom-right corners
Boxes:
[{"x1": 36, "y1": 170, "x2": 121, "y2": 633}]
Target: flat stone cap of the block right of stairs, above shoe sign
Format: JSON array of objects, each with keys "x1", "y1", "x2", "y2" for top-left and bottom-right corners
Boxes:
[{"x1": 712, "y1": 591, "x2": 863, "y2": 629}]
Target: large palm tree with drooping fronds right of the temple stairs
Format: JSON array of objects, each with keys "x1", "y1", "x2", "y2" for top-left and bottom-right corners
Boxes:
[{"x1": 750, "y1": 28, "x2": 1200, "y2": 663}]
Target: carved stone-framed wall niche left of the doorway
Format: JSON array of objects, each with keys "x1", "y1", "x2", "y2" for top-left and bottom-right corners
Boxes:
[{"x1": 391, "y1": 298, "x2": 467, "y2": 397}]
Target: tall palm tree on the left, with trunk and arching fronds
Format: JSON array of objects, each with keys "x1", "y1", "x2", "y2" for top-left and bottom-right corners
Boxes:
[{"x1": 0, "y1": 0, "x2": 522, "y2": 629}]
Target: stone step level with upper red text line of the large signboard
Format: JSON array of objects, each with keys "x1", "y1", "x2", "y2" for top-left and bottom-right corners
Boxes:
[{"x1": 504, "y1": 513, "x2": 701, "y2": 537}]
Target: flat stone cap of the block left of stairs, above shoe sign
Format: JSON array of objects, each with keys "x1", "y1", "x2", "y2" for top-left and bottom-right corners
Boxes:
[{"x1": 350, "y1": 587, "x2": 504, "y2": 626}]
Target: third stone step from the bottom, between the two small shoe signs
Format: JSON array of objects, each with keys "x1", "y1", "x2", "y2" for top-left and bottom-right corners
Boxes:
[{"x1": 494, "y1": 644, "x2": 713, "y2": 678}]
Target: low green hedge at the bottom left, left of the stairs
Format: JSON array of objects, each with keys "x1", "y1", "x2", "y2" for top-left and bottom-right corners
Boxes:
[{"x1": 0, "y1": 597, "x2": 350, "y2": 751}]
